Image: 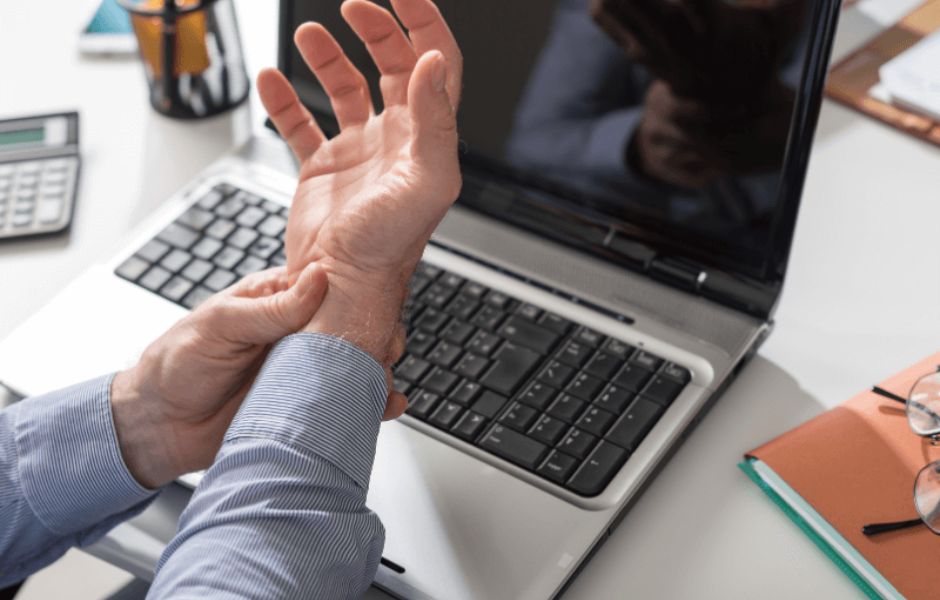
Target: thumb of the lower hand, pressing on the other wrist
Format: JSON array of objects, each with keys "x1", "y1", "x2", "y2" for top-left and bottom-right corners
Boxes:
[{"x1": 230, "y1": 264, "x2": 327, "y2": 344}]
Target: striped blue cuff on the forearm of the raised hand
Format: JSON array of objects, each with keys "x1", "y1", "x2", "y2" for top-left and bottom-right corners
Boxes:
[{"x1": 225, "y1": 333, "x2": 388, "y2": 489}]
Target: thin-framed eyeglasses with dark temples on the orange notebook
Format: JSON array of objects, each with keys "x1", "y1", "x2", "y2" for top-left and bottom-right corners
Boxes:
[{"x1": 862, "y1": 367, "x2": 940, "y2": 536}]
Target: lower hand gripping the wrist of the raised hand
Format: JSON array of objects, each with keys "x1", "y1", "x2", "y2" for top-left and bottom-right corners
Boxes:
[{"x1": 111, "y1": 265, "x2": 404, "y2": 488}]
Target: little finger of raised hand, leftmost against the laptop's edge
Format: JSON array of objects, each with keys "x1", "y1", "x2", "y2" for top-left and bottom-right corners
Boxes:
[{"x1": 258, "y1": 69, "x2": 326, "y2": 162}]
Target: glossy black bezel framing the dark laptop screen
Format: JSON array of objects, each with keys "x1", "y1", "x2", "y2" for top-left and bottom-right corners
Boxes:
[{"x1": 278, "y1": 0, "x2": 841, "y2": 319}]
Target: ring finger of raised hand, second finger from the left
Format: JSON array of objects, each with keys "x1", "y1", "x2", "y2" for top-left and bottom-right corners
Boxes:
[{"x1": 294, "y1": 23, "x2": 372, "y2": 127}]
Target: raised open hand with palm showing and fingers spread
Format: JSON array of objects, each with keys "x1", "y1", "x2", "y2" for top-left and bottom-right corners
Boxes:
[{"x1": 258, "y1": 0, "x2": 462, "y2": 368}]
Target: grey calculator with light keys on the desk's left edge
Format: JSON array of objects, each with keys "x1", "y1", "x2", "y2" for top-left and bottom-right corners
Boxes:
[{"x1": 0, "y1": 112, "x2": 80, "y2": 240}]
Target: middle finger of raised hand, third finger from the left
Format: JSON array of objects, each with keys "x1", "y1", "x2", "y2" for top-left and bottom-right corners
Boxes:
[{"x1": 341, "y1": 0, "x2": 418, "y2": 106}]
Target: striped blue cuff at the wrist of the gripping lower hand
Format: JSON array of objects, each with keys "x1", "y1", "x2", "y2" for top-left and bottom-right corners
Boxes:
[{"x1": 15, "y1": 375, "x2": 154, "y2": 534}]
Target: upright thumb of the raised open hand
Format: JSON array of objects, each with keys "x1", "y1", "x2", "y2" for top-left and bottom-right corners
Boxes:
[{"x1": 408, "y1": 50, "x2": 457, "y2": 161}]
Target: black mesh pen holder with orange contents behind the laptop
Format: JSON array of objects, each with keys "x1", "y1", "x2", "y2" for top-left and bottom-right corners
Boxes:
[{"x1": 119, "y1": 0, "x2": 248, "y2": 119}]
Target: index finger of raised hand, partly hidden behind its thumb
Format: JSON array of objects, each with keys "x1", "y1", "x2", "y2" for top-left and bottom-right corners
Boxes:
[{"x1": 392, "y1": 0, "x2": 463, "y2": 112}]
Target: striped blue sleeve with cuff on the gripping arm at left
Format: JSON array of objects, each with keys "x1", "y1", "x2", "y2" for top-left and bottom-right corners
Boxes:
[{"x1": 0, "y1": 376, "x2": 154, "y2": 588}]
